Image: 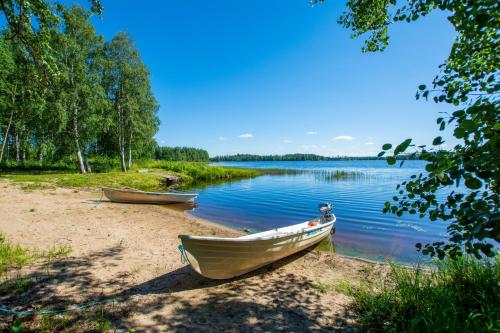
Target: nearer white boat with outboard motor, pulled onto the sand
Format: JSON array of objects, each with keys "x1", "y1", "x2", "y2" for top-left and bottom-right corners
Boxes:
[{"x1": 179, "y1": 204, "x2": 336, "y2": 279}]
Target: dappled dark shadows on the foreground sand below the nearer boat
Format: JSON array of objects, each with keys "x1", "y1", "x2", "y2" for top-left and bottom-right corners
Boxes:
[{"x1": 0, "y1": 246, "x2": 358, "y2": 332}]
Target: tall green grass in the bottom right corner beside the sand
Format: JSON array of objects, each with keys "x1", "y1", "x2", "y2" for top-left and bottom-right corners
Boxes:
[{"x1": 340, "y1": 257, "x2": 500, "y2": 332}]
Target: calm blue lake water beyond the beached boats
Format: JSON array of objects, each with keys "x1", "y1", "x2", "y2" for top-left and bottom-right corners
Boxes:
[{"x1": 189, "y1": 160, "x2": 446, "y2": 262}]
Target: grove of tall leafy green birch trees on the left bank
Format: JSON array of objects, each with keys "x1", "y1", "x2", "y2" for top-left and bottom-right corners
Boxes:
[{"x1": 0, "y1": 5, "x2": 159, "y2": 173}]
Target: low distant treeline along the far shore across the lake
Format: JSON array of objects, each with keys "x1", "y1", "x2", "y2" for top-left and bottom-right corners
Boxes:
[{"x1": 210, "y1": 154, "x2": 418, "y2": 162}]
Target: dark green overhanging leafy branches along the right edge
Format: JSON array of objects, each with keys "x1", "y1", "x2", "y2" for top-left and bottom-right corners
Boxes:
[{"x1": 326, "y1": 0, "x2": 500, "y2": 258}]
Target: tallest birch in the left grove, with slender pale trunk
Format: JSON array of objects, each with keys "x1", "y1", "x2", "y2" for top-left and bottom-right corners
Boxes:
[{"x1": 55, "y1": 6, "x2": 105, "y2": 173}]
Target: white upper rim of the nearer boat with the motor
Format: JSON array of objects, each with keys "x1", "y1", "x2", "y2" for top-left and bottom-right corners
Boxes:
[{"x1": 178, "y1": 214, "x2": 337, "y2": 242}]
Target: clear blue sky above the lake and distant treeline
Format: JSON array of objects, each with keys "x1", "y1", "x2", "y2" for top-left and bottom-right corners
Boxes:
[{"x1": 82, "y1": 0, "x2": 454, "y2": 156}]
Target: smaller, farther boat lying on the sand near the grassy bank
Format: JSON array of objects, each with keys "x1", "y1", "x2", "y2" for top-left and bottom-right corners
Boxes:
[{"x1": 102, "y1": 187, "x2": 198, "y2": 205}]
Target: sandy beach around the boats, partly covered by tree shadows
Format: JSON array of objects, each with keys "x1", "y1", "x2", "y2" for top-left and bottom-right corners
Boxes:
[{"x1": 0, "y1": 180, "x2": 382, "y2": 332}]
